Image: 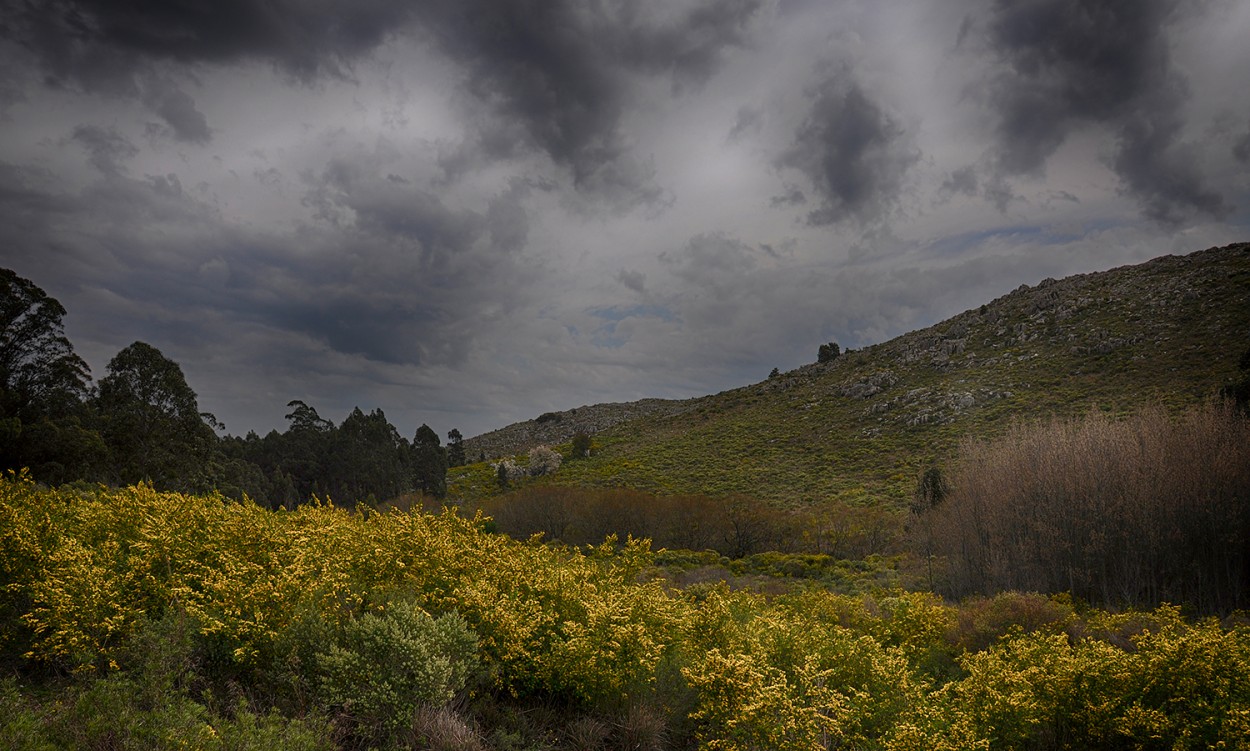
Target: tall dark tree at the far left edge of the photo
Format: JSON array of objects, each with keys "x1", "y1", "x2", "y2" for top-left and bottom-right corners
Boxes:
[{"x1": 0, "y1": 269, "x2": 104, "y2": 482}]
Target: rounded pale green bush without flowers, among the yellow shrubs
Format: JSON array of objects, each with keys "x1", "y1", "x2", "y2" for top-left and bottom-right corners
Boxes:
[{"x1": 316, "y1": 602, "x2": 478, "y2": 737}]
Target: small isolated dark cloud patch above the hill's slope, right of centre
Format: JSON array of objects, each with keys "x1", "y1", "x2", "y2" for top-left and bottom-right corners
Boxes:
[{"x1": 774, "y1": 65, "x2": 919, "y2": 225}]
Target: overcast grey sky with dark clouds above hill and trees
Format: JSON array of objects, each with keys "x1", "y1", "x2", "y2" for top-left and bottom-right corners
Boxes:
[{"x1": 0, "y1": 0, "x2": 1250, "y2": 437}]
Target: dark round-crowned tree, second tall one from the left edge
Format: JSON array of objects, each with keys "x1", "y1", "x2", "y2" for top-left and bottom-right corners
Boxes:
[{"x1": 95, "y1": 341, "x2": 216, "y2": 490}]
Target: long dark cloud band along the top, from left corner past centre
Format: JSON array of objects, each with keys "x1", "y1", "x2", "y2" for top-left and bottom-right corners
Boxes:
[{"x1": 7, "y1": 0, "x2": 763, "y2": 204}]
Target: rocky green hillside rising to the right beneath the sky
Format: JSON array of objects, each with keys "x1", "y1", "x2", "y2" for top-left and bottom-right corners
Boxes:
[{"x1": 449, "y1": 244, "x2": 1250, "y2": 505}]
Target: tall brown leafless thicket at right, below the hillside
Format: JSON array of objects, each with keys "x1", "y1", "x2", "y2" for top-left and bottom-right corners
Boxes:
[{"x1": 916, "y1": 402, "x2": 1250, "y2": 612}]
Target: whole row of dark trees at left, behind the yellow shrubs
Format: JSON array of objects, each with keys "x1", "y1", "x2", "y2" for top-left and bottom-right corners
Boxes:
[{"x1": 0, "y1": 269, "x2": 465, "y2": 507}]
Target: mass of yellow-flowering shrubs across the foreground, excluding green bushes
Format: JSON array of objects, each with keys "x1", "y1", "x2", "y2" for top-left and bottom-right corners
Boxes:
[{"x1": 7, "y1": 475, "x2": 1250, "y2": 751}]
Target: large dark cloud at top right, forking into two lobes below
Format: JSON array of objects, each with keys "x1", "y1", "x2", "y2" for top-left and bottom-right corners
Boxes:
[{"x1": 961, "y1": 0, "x2": 1228, "y2": 224}]
